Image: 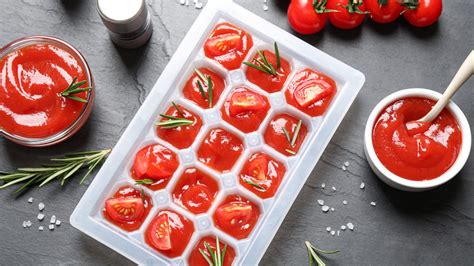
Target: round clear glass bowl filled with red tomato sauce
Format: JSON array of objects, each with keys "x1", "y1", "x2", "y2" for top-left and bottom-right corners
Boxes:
[{"x1": 0, "y1": 36, "x2": 95, "y2": 147}]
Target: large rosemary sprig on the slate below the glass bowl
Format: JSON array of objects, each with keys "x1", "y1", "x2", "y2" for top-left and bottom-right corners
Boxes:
[{"x1": 0, "y1": 149, "x2": 111, "y2": 193}]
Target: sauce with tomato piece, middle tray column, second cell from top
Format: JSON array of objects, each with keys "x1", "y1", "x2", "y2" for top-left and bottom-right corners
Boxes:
[{"x1": 221, "y1": 87, "x2": 270, "y2": 133}]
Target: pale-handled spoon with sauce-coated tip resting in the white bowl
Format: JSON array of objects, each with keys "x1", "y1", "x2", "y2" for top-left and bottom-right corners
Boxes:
[{"x1": 406, "y1": 50, "x2": 474, "y2": 135}]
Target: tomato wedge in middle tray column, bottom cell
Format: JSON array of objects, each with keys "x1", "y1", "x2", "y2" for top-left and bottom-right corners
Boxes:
[{"x1": 150, "y1": 213, "x2": 172, "y2": 250}]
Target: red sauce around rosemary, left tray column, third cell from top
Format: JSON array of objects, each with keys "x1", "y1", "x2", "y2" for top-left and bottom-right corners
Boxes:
[{"x1": 156, "y1": 104, "x2": 202, "y2": 149}]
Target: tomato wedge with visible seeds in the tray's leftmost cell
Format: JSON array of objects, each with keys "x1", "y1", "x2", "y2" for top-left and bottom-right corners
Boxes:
[{"x1": 105, "y1": 198, "x2": 145, "y2": 223}]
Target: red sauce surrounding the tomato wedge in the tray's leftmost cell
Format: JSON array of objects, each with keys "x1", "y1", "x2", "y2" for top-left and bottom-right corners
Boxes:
[{"x1": 102, "y1": 186, "x2": 153, "y2": 232}]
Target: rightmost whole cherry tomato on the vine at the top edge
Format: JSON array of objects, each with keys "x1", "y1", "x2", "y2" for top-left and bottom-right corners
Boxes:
[{"x1": 403, "y1": 0, "x2": 443, "y2": 27}]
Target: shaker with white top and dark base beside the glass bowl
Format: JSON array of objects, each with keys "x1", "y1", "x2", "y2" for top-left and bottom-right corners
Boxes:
[{"x1": 97, "y1": 0, "x2": 153, "y2": 49}]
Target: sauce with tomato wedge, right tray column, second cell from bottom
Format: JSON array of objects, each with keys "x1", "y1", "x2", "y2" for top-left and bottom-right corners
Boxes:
[{"x1": 214, "y1": 195, "x2": 260, "y2": 239}]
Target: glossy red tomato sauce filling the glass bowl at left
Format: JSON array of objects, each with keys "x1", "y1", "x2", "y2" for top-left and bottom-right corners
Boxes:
[{"x1": 0, "y1": 44, "x2": 89, "y2": 138}]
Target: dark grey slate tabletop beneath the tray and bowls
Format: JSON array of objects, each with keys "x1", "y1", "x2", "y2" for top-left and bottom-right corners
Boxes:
[{"x1": 0, "y1": 0, "x2": 474, "y2": 265}]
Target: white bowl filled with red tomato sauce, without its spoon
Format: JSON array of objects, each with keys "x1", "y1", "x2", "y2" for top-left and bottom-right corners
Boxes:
[{"x1": 364, "y1": 88, "x2": 471, "y2": 191}]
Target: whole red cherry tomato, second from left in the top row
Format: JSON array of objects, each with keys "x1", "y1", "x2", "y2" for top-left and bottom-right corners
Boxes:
[{"x1": 326, "y1": 0, "x2": 365, "y2": 30}]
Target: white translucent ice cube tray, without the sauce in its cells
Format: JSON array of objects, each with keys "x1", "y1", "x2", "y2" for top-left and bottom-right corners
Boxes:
[{"x1": 71, "y1": 0, "x2": 365, "y2": 265}]
